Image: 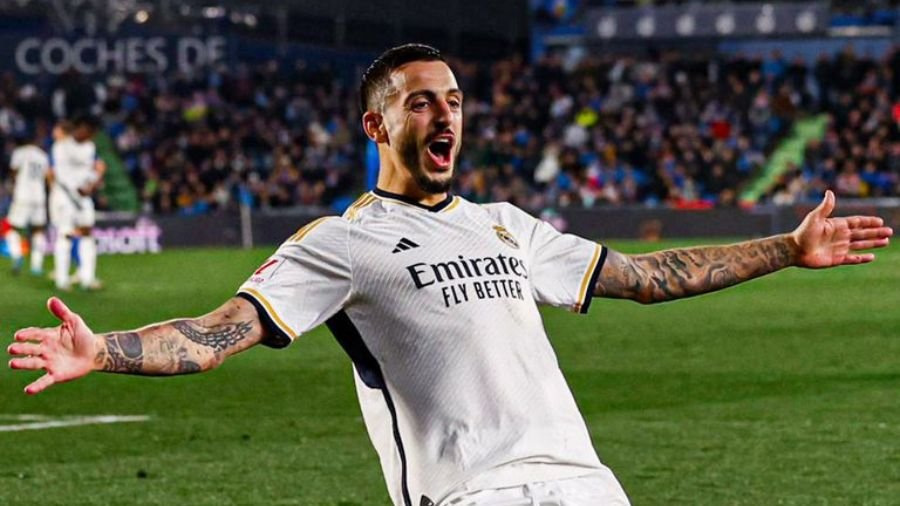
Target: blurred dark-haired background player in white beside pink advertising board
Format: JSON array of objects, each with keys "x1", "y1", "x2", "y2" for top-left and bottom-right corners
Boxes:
[{"x1": 50, "y1": 116, "x2": 106, "y2": 290}]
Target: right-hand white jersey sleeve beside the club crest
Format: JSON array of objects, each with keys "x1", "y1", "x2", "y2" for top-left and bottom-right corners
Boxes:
[{"x1": 492, "y1": 204, "x2": 606, "y2": 313}]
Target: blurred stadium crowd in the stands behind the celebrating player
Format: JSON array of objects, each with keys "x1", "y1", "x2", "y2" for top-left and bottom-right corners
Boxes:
[{"x1": 0, "y1": 45, "x2": 900, "y2": 214}]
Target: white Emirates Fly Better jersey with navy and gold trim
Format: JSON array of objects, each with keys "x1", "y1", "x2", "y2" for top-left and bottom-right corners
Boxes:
[{"x1": 239, "y1": 190, "x2": 606, "y2": 506}]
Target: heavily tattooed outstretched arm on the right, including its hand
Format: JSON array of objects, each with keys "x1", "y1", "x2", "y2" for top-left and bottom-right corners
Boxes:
[{"x1": 594, "y1": 191, "x2": 893, "y2": 304}]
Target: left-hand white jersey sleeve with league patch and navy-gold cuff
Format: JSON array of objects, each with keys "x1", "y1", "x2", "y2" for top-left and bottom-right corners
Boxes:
[{"x1": 237, "y1": 217, "x2": 351, "y2": 348}]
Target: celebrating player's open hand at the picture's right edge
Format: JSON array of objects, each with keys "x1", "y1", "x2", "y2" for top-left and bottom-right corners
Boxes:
[{"x1": 792, "y1": 191, "x2": 894, "y2": 269}]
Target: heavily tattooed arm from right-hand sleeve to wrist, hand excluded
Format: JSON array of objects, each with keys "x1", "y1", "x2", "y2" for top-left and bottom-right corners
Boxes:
[{"x1": 595, "y1": 236, "x2": 796, "y2": 303}]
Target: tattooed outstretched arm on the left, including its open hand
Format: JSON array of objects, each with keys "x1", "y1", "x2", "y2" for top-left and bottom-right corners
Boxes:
[{"x1": 8, "y1": 297, "x2": 266, "y2": 394}]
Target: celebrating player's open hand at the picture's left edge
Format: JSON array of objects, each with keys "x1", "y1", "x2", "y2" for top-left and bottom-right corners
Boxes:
[{"x1": 7, "y1": 297, "x2": 100, "y2": 395}]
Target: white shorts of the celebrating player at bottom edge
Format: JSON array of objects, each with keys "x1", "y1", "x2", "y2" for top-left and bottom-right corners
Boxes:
[{"x1": 441, "y1": 469, "x2": 631, "y2": 506}]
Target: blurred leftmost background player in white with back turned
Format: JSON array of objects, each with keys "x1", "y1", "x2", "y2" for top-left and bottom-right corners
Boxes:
[{"x1": 6, "y1": 131, "x2": 50, "y2": 276}]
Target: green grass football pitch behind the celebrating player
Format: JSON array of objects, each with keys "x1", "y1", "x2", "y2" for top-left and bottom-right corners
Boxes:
[{"x1": 0, "y1": 242, "x2": 900, "y2": 506}]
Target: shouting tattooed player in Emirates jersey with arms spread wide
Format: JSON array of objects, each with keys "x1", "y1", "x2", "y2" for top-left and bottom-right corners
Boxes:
[{"x1": 9, "y1": 45, "x2": 893, "y2": 506}]
